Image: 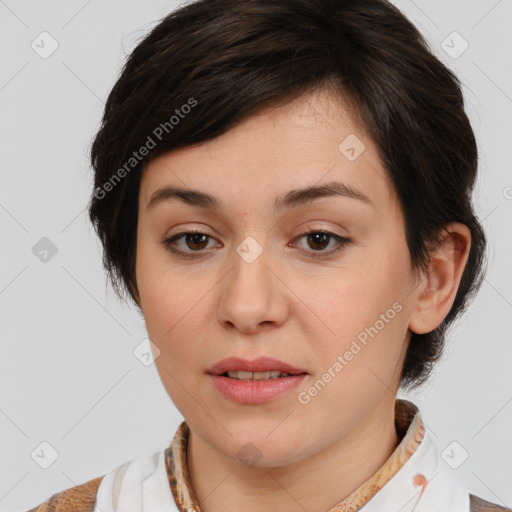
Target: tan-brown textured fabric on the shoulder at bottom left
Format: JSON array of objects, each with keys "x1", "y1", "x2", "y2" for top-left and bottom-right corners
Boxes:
[{"x1": 27, "y1": 475, "x2": 105, "y2": 512}]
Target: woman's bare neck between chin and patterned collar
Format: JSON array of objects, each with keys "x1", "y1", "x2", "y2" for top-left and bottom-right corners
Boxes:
[{"x1": 187, "y1": 399, "x2": 398, "y2": 512}]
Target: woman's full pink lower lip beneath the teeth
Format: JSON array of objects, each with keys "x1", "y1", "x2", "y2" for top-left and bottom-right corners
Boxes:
[{"x1": 208, "y1": 373, "x2": 307, "y2": 404}]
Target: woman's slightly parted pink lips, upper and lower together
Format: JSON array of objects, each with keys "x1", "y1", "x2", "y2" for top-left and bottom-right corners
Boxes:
[{"x1": 207, "y1": 357, "x2": 308, "y2": 405}]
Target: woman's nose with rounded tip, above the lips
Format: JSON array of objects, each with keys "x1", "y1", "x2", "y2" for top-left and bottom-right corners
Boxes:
[{"x1": 217, "y1": 238, "x2": 289, "y2": 334}]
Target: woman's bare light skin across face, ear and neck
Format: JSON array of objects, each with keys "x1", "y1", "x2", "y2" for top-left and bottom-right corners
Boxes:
[{"x1": 133, "y1": 91, "x2": 470, "y2": 512}]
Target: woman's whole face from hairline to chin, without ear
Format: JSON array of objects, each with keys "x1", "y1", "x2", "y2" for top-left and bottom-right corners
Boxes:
[{"x1": 136, "y1": 92, "x2": 422, "y2": 466}]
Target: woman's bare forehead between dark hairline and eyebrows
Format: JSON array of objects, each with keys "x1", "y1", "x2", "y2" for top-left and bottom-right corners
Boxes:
[{"x1": 140, "y1": 91, "x2": 396, "y2": 213}]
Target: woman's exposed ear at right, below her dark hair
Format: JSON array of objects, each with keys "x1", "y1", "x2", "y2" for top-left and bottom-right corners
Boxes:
[{"x1": 409, "y1": 222, "x2": 471, "y2": 334}]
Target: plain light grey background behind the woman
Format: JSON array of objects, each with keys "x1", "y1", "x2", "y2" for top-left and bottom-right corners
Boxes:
[{"x1": 0, "y1": 0, "x2": 512, "y2": 512}]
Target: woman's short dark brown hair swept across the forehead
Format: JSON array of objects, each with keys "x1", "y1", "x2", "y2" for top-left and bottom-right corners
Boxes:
[{"x1": 89, "y1": 0, "x2": 486, "y2": 389}]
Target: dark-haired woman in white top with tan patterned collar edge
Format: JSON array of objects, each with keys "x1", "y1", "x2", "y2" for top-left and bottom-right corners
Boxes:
[{"x1": 23, "y1": 0, "x2": 510, "y2": 512}]
